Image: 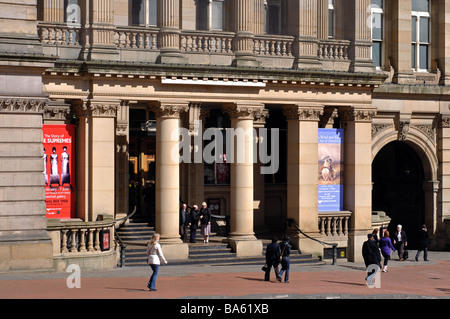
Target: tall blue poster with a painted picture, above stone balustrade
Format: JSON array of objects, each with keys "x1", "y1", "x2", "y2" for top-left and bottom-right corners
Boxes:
[{"x1": 318, "y1": 129, "x2": 344, "y2": 212}]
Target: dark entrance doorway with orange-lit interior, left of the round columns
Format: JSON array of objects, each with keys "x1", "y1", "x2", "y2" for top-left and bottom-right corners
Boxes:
[{"x1": 129, "y1": 109, "x2": 156, "y2": 226}]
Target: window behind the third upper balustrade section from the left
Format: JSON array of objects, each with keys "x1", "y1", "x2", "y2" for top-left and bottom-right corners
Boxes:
[{"x1": 197, "y1": 0, "x2": 225, "y2": 31}]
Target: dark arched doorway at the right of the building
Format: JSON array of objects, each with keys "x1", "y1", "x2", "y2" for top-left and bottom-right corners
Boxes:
[{"x1": 372, "y1": 141, "x2": 425, "y2": 249}]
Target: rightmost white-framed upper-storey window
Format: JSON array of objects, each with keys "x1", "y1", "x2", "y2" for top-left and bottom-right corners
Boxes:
[{"x1": 411, "y1": 0, "x2": 430, "y2": 71}]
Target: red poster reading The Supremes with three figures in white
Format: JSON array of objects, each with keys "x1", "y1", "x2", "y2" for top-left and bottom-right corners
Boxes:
[{"x1": 42, "y1": 124, "x2": 75, "y2": 219}]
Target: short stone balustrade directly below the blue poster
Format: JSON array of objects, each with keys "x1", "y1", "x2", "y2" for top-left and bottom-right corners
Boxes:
[{"x1": 319, "y1": 211, "x2": 352, "y2": 237}]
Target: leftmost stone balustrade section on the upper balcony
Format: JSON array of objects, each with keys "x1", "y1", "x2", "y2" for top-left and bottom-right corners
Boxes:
[{"x1": 38, "y1": 22, "x2": 80, "y2": 46}]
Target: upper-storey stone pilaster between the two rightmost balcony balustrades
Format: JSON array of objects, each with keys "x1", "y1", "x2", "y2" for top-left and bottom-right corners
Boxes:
[{"x1": 287, "y1": 0, "x2": 321, "y2": 69}]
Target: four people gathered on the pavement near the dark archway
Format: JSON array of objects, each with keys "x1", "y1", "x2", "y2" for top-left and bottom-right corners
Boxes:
[{"x1": 362, "y1": 225, "x2": 429, "y2": 283}]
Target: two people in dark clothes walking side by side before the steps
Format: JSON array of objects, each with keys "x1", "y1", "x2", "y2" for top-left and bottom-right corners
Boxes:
[{"x1": 263, "y1": 235, "x2": 292, "y2": 283}]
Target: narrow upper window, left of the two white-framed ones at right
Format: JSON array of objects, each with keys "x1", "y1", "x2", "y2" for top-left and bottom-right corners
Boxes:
[{"x1": 371, "y1": 0, "x2": 384, "y2": 68}]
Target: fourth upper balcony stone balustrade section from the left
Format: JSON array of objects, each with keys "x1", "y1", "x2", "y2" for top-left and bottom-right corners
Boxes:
[{"x1": 253, "y1": 35, "x2": 294, "y2": 56}]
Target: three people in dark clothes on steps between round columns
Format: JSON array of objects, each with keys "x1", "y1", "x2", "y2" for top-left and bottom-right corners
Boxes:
[{"x1": 180, "y1": 202, "x2": 211, "y2": 243}]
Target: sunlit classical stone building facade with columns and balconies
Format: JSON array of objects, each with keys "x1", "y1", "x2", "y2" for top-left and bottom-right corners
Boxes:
[{"x1": 0, "y1": 0, "x2": 450, "y2": 271}]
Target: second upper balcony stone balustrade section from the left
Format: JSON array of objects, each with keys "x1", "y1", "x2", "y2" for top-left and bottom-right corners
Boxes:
[{"x1": 114, "y1": 27, "x2": 159, "y2": 50}]
